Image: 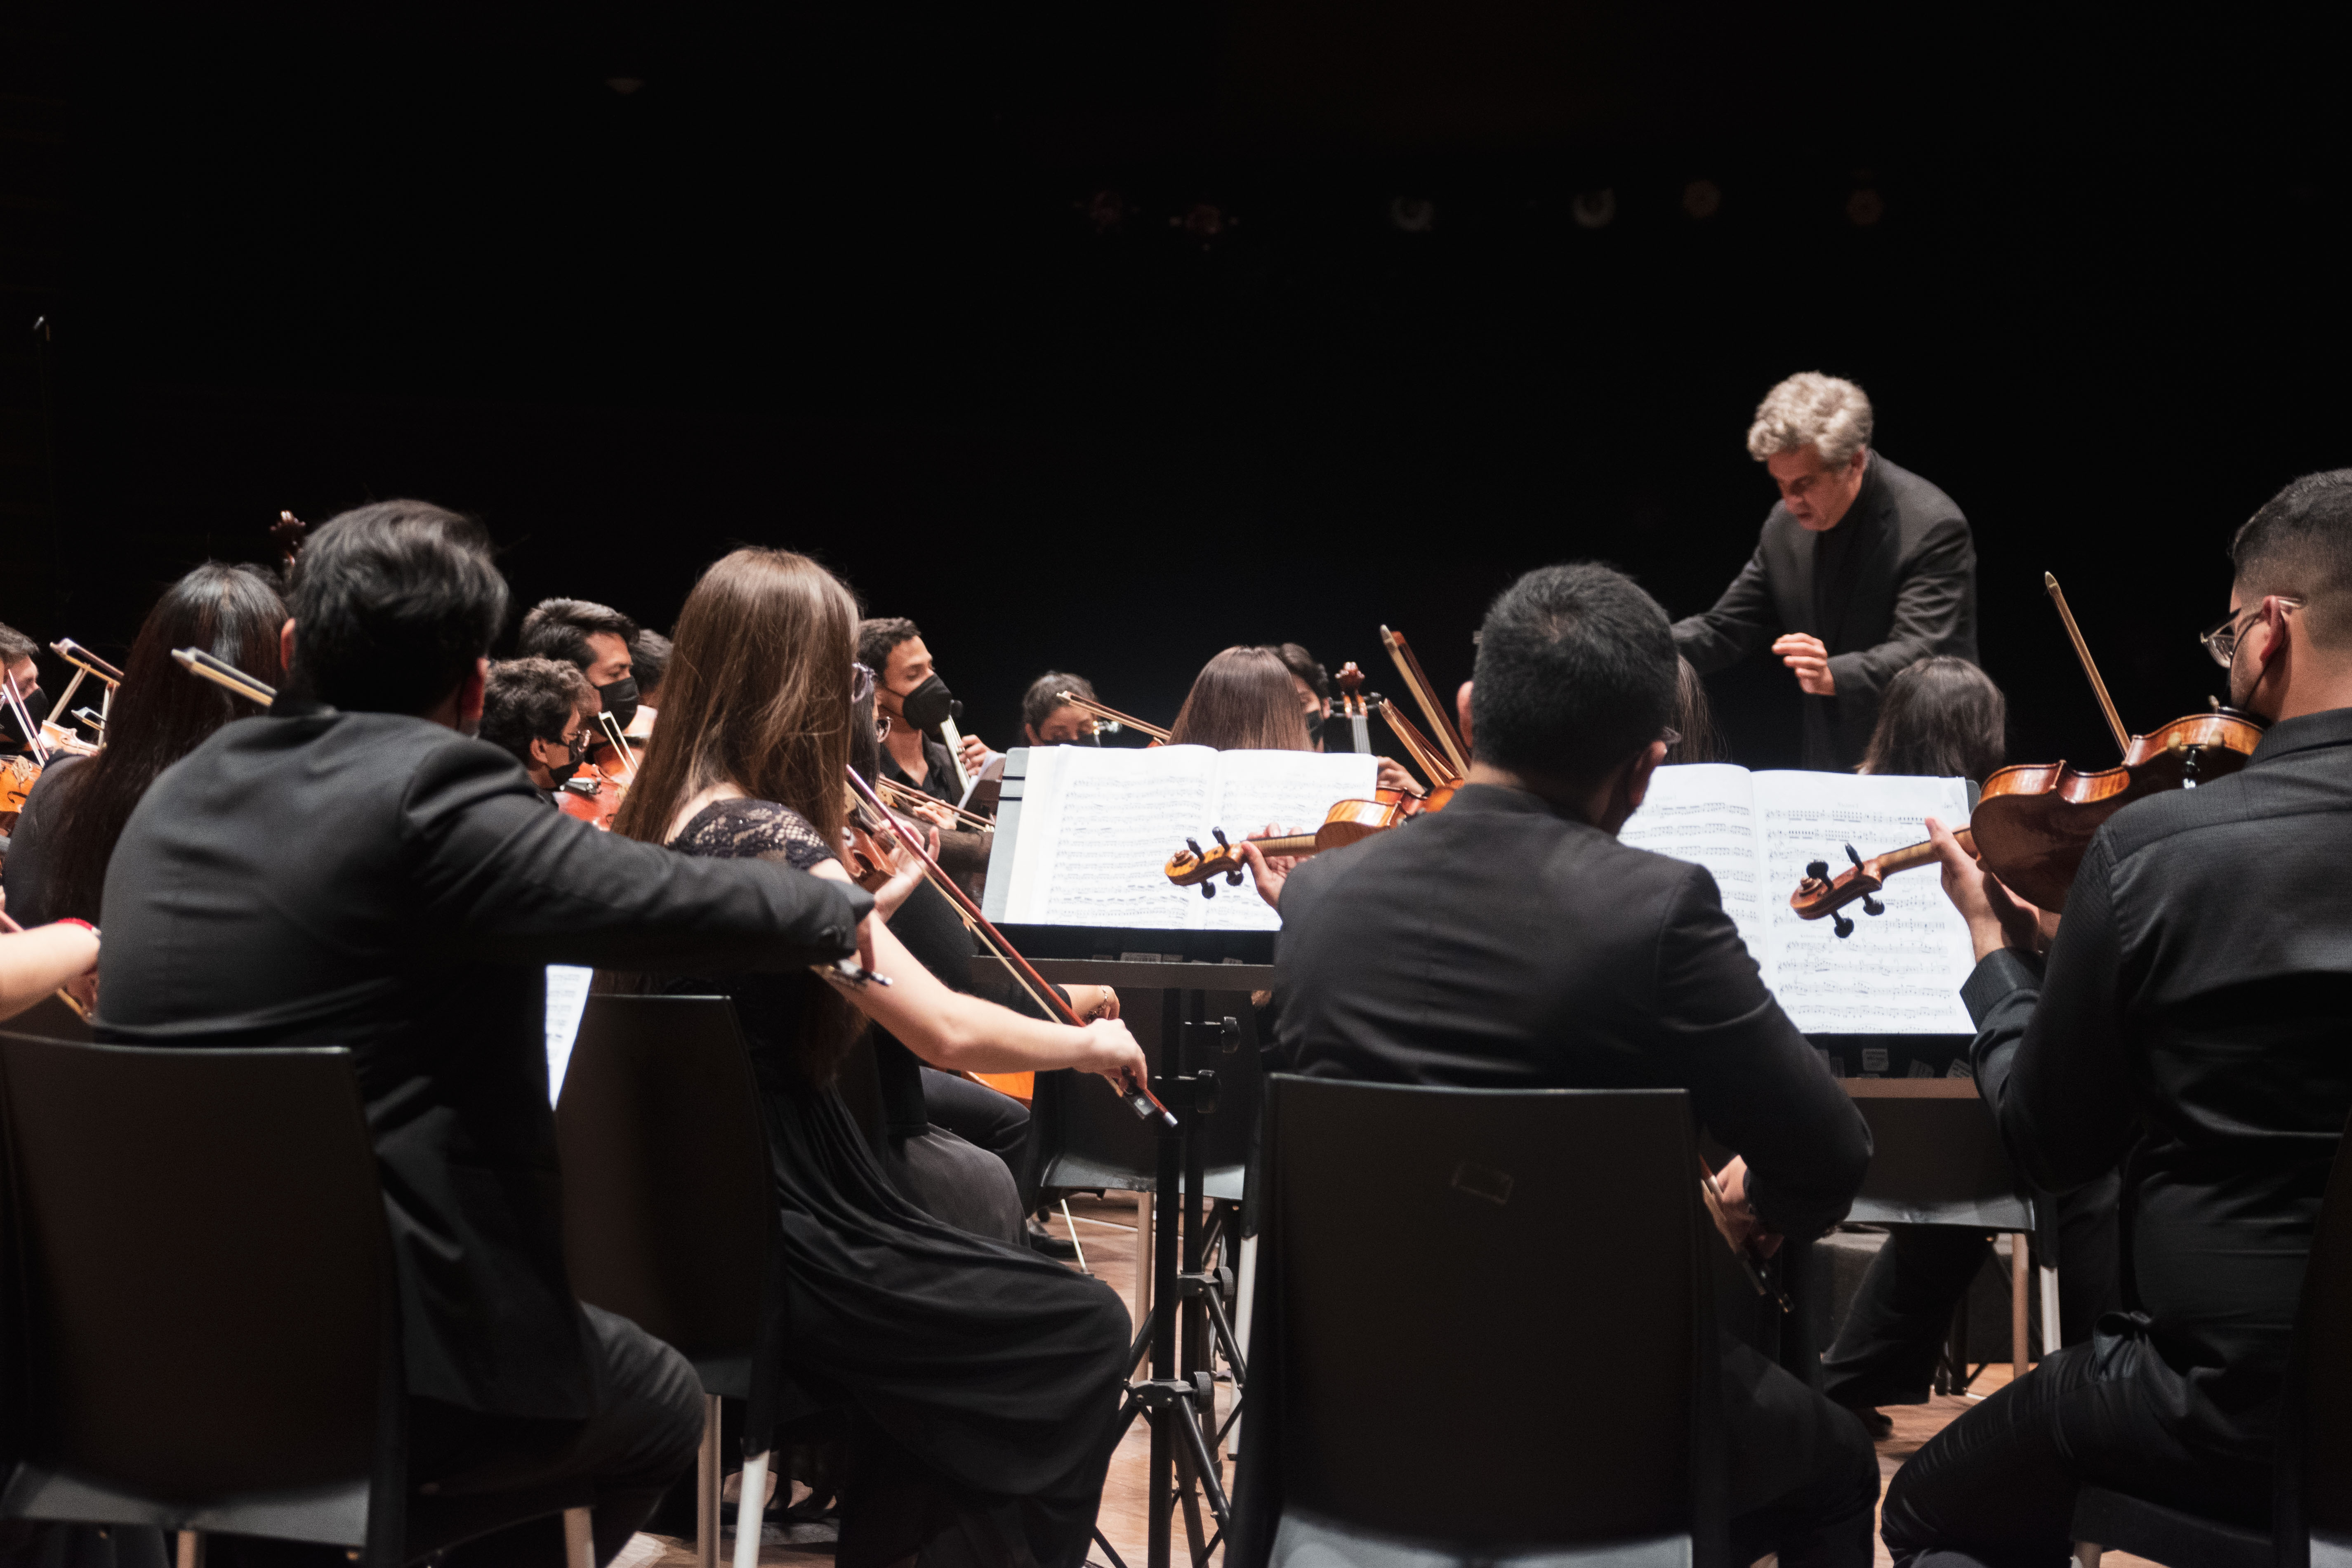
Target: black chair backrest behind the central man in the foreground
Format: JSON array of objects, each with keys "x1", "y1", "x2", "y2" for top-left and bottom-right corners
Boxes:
[{"x1": 1233, "y1": 1077, "x2": 1726, "y2": 1568}]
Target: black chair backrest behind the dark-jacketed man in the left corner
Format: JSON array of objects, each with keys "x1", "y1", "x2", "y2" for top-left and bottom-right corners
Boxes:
[{"x1": 0, "y1": 1034, "x2": 405, "y2": 1561}]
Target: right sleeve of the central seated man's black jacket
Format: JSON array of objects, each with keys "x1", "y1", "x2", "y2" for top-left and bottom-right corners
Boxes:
[{"x1": 1654, "y1": 865, "x2": 1870, "y2": 1239}]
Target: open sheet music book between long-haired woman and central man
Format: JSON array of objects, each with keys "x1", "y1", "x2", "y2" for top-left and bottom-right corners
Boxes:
[{"x1": 983, "y1": 745, "x2": 1381, "y2": 931}]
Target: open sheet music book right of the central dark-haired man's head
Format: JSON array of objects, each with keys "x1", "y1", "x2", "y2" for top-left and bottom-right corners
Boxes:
[{"x1": 1618, "y1": 762, "x2": 1976, "y2": 1034}]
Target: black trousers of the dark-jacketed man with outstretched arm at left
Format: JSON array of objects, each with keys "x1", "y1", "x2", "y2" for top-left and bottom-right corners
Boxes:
[{"x1": 209, "y1": 1307, "x2": 703, "y2": 1568}]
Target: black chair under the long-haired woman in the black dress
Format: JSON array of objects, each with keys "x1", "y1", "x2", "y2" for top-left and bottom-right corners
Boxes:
[{"x1": 555, "y1": 997, "x2": 783, "y2": 1568}]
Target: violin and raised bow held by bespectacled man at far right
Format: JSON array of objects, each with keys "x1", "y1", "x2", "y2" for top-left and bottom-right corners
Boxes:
[{"x1": 1788, "y1": 571, "x2": 2265, "y2": 936}]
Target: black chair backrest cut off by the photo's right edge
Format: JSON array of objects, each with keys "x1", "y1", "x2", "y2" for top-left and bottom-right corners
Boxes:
[{"x1": 2277, "y1": 1105, "x2": 2352, "y2": 1568}]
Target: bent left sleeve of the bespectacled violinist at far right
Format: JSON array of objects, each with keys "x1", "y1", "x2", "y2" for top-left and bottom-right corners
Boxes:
[{"x1": 1959, "y1": 832, "x2": 2133, "y2": 1192}]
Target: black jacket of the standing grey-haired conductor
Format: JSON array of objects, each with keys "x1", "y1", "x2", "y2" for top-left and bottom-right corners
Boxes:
[{"x1": 1675, "y1": 451, "x2": 1976, "y2": 771}]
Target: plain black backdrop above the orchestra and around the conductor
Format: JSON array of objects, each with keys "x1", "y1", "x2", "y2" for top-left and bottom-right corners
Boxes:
[{"x1": 0, "y1": 0, "x2": 2352, "y2": 764}]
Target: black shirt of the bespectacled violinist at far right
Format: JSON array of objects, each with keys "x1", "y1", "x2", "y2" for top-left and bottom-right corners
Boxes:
[{"x1": 1961, "y1": 707, "x2": 2352, "y2": 1462}]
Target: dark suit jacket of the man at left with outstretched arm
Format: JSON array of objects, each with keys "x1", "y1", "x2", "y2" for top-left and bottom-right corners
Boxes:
[{"x1": 99, "y1": 700, "x2": 872, "y2": 1417}]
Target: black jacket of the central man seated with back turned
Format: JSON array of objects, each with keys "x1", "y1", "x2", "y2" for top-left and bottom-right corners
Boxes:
[{"x1": 1275, "y1": 785, "x2": 1870, "y2": 1236}]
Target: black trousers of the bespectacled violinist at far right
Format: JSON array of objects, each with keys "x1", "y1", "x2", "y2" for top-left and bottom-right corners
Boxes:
[{"x1": 1882, "y1": 1314, "x2": 2270, "y2": 1568}]
